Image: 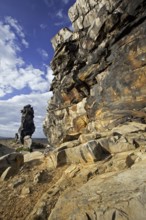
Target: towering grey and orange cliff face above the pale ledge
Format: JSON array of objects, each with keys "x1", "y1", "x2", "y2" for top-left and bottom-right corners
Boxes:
[{"x1": 44, "y1": 0, "x2": 146, "y2": 146}]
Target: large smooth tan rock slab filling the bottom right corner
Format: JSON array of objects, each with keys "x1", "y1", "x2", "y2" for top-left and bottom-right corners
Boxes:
[{"x1": 48, "y1": 158, "x2": 146, "y2": 220}]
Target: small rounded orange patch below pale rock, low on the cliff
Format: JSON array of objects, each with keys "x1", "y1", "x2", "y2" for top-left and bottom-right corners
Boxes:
[{"x1": 73, "y1": 115, "x2": 88, "y2": 132}]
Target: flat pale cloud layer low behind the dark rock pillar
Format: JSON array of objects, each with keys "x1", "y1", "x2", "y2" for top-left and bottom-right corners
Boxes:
[{"x1": 0, "y1": 92, "x2": 52, "y2": 138}]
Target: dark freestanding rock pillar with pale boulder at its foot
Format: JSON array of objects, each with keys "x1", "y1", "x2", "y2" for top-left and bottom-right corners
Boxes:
[{"x1": 18, "y1": 104, "x2": 35, "y2": 151}]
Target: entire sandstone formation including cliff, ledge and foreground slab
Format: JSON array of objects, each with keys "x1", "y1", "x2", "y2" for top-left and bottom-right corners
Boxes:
[{"x1": 40, "y1": 0, "x2": 146, "y2": 220}]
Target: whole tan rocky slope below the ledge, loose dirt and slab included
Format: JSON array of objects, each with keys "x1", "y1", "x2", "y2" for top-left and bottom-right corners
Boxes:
[{"x1": 0, "y1": 147, "x2": 146, "y2": 220}]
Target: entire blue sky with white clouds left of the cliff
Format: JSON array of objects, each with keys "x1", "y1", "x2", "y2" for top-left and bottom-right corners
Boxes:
[{"x1": 0, "y1": 0, "x2": 75, "y2": 137}]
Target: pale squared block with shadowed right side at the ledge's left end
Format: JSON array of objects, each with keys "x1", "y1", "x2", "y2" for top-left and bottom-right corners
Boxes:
[{"x1": 47, "y1": 140, "x2": 103, "y2": 168}]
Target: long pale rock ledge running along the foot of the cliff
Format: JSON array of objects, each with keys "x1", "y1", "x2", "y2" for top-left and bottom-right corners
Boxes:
[{"x1": 46, "y1": 122, "x2": 146, "y2": 168}]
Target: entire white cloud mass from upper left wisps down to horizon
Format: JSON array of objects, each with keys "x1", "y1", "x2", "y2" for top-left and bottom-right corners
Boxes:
[{"x1": 0, "y1": 17, "x2": 52, "y2": 137}]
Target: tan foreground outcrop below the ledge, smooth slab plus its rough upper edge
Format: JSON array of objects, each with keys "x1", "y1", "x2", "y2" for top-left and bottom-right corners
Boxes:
[{"x1": 27, "y1": 149, "x2": 146, "y2": 220}]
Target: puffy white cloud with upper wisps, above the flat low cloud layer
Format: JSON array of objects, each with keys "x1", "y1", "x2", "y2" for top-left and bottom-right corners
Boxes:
[{"x1": 0, "y1": 17, "x2": 49, "y2": 97}]
